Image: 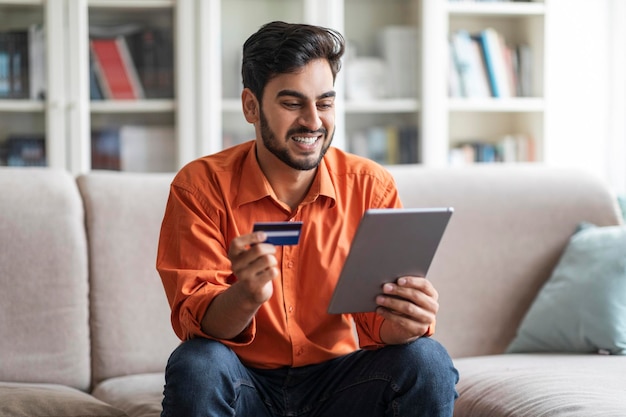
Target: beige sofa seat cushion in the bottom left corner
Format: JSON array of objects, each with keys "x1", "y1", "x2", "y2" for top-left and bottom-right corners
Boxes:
[{"x1": 0, "y1": 382, "x2": 126, "y2": 417}]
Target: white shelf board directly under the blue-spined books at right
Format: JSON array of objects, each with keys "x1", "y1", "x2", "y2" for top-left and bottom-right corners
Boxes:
[{"x1": 448, "y1": 97, "x2": 545, "y2": 113}]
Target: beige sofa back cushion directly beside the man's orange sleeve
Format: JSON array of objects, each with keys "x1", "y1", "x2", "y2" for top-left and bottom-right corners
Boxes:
[{"x1": 77, "y1": 172, "x2": 179, "y2": 384}]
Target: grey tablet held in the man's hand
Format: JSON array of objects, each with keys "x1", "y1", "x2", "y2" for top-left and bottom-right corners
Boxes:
[{"x1": 328, "y1": 207, "x2": 453, "y2": 314}]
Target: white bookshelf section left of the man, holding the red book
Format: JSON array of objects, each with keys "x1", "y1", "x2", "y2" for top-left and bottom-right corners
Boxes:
[{"x1": 0, "y1": 0, "x2": 194, "y2": 173}]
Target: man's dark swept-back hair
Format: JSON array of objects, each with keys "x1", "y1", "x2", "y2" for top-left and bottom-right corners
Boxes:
[{"x1": 241, "y1": 21, "x2": 345, "y2": 101}]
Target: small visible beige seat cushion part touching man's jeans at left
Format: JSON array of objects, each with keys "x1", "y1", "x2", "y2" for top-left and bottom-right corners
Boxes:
[{"x1": 92, "y1": 372, "x2": 165, "y2": 417}]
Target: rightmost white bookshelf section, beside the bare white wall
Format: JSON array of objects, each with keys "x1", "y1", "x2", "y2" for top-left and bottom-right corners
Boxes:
[{"x1": 422, "y1": 0, "x2": 547, "y2": 166}]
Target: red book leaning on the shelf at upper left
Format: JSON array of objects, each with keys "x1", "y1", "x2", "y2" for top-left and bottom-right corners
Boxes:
[{"x1": 90, "y1": 36, "x2": 144, "y2": 100}]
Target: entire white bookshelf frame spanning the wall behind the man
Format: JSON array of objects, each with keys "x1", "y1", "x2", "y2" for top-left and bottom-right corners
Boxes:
[{"x1": 0, "y1": 0, "x2": 548, "y2": 173}]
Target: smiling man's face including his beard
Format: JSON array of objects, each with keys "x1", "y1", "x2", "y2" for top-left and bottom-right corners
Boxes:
[{"x1": 254, "y1": 59, "x2": 335, "y2": 171}]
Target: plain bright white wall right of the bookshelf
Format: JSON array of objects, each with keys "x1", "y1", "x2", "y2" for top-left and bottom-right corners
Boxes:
[{"x1": 546, "y1": 0, "x2": 626, "y2": 192}]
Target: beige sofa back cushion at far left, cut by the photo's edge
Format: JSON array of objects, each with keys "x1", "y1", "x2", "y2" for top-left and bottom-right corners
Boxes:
[{"x1": 0, "y1": 167, "x2": 91, "y2": 390}]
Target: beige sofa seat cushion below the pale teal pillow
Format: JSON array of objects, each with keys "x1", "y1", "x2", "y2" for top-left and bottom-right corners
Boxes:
[{"x1": 454, "y1": 354, "x2": 626, "y2": 417}]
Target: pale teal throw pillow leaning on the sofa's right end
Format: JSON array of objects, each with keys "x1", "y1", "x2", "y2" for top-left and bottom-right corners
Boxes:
[{"x1": 507, "y1": 223, "x2": 626, "y2": 355}]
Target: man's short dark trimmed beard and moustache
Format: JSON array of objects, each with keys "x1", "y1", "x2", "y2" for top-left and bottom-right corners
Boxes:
[{"x1": 260, "y1": 109, "x2": 335, "y2": 171}]
